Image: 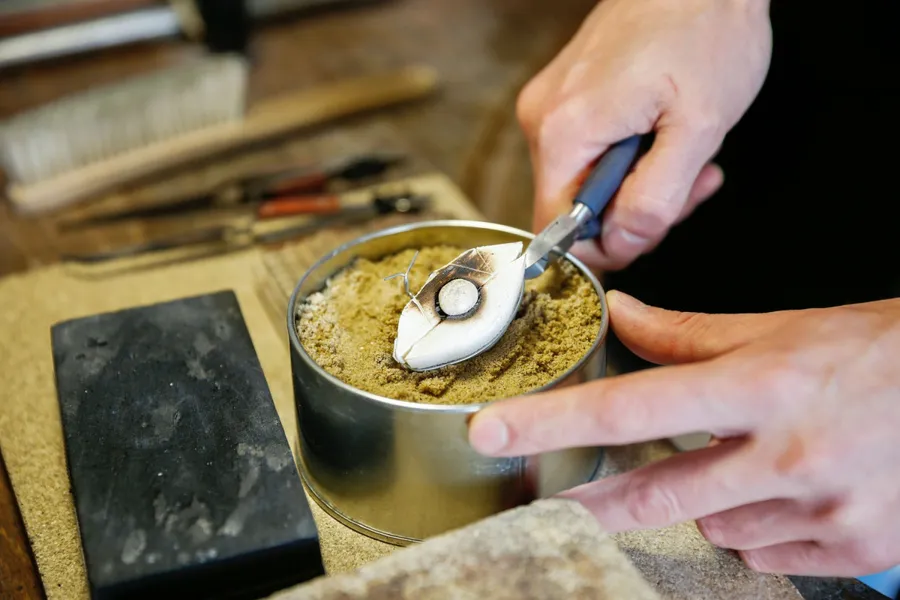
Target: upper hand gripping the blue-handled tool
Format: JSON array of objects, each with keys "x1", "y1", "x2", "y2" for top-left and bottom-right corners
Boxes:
[{"x1": 517, "y1": 0, "x2": 771, "y2": 269}]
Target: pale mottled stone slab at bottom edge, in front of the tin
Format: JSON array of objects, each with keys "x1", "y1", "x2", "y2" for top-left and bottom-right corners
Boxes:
[{"x1": 271, "y1": 500, "x2": 660, "y2": 600}]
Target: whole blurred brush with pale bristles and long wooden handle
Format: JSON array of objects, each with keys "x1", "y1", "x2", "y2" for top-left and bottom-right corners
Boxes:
[{"x1": 0, "y1": 54, "x2": 437, "y2": 215}]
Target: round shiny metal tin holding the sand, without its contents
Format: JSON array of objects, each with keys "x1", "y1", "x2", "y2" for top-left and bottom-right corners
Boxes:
[{"x1": 287, "y1": 220, "x2": 609, "y2": 545}]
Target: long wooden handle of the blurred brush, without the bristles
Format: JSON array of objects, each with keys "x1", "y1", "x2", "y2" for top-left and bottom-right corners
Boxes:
[{"x1": 7, "y1": 66, "x2": 437, "y2": 215}]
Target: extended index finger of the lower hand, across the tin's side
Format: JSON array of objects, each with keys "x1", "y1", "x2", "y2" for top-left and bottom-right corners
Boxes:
[{"x1": 469, "y1": 358, "x2": 758, "y2": 456}]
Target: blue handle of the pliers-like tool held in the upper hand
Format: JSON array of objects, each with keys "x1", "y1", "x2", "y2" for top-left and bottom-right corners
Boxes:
[{"x1": 575, "y1": 135, "x2": 643, "y2": 240}]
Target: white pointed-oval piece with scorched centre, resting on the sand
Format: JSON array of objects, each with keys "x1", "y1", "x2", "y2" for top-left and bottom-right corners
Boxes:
[{"x1": 394, "y1": 242, "x2": 525, "y2": 371}]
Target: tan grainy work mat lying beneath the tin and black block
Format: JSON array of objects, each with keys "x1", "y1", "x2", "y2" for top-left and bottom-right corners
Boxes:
[{"x1": 0, "y1": 174, "x2": 799, "y2": 600}]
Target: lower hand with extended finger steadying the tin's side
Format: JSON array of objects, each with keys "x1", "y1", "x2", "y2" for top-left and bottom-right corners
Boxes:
[{"x1": 469, "y1": 292, "x2": 900, "y2": 577}]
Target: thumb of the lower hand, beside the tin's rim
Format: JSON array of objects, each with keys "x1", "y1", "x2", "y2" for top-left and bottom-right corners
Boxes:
[{"x1": 606, "y1": 291, "x2": 796, "y2": 365}]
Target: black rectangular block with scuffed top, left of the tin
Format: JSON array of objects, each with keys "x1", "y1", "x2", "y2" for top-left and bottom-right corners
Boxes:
[{"x1": 51, "y1": 291, "x2": 324, "y2": 600}]
